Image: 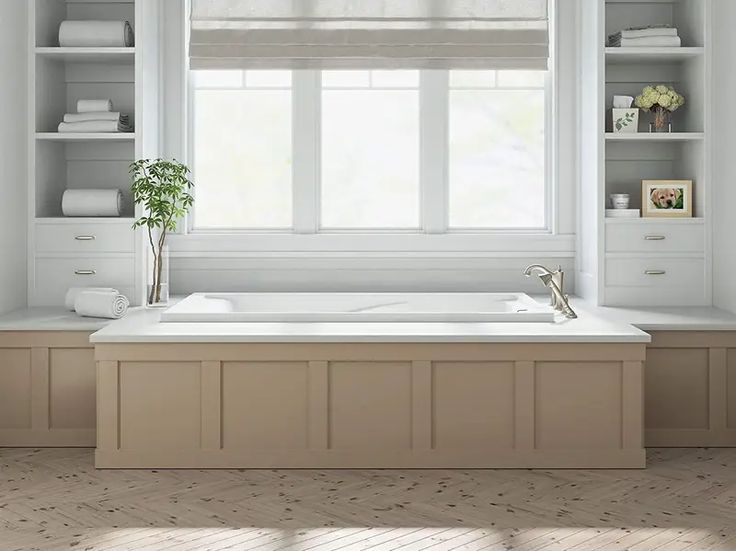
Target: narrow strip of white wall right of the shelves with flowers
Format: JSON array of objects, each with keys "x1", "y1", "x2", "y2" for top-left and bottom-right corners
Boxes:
[{"x1": 711, "y1": 0, "x2": 736, "y2": 312}]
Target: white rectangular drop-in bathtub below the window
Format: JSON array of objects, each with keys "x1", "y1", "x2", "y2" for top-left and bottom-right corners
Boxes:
[{"x1": 161, "y1": 293, "x2": 554, "y2": 322}]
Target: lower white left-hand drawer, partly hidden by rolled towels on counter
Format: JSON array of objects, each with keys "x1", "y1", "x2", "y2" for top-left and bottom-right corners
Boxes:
[{"x1": 33, "y1": 255, "x2": 135, "y2": 306}]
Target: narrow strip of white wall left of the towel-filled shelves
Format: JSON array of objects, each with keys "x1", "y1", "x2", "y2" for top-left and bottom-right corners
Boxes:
[{"x1": 0, "y1": 0, "x2": 28, "y2": 313}]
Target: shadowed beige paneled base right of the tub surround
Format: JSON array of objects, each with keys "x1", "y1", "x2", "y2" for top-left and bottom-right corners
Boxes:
[{"x1": 645, "y1": 331, "x2": 736, "y2": 447}]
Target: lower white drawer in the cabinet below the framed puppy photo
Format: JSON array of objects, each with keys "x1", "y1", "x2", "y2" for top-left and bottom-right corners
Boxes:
[{"x1": 606, "y1": 256, "x2": 705, "y2": 288}]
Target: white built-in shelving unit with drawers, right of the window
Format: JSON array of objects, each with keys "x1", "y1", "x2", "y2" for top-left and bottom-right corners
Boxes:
[{"x1": 578, "y1": 0, "x2": 712, "y2": 306}]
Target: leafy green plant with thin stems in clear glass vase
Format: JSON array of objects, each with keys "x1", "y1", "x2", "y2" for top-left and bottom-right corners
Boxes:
[{"x1": 130, "y1": 159, "x2": 194, "y2": 306}]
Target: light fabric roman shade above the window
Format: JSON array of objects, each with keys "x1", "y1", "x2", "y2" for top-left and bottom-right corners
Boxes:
[{"x1": 189, "y1": 0, "x2": 549, "y2": 69}]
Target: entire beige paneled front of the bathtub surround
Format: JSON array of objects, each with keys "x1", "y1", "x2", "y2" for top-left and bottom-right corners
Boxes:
[{"x1": 96, "y1": 343, "x2": 645, "y2": 468}]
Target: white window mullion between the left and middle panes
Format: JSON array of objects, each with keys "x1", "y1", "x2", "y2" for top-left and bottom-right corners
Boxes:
[{"x1": 292, "y1": 71, "x2": 321, "y2": 233}]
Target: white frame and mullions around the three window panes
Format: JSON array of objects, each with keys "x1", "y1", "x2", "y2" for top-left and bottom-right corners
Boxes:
[{"x1": 182, "y1": 67, "x2": 557, "y2": 235}]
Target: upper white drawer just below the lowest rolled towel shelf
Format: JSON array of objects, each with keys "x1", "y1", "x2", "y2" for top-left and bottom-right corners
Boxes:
[{"x1": 36, "y1": 222, "x2": 135, "y2": 254}]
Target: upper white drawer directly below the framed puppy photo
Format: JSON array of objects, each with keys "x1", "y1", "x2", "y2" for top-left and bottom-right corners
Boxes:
[{"x1": 606, "y1": 222, "x2": 705, "y2": 253}]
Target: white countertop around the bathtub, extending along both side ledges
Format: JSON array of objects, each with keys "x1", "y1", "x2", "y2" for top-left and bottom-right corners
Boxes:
[{"x1": 0, "y1": 297, "x2": 736, "y2": 343}]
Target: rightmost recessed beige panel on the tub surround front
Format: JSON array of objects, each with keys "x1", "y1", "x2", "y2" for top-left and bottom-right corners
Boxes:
[{"x1": 535, "y1": 362, "x2": 622, "y2": 450}]
